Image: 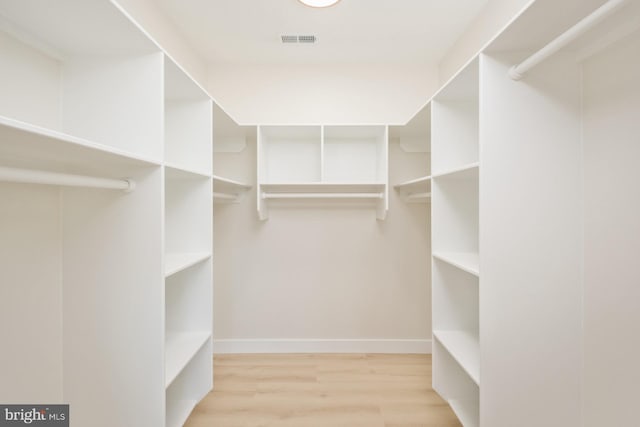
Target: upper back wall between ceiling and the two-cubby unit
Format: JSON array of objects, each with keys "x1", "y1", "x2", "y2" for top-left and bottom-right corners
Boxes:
[{"x1": 208, "y1": 64, "x2": 438, "y2": 124}]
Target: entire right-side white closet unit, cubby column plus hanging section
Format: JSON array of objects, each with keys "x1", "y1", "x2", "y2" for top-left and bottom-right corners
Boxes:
[{"x1": 432, "y1": 0, "x2": 640, "y2": 427}]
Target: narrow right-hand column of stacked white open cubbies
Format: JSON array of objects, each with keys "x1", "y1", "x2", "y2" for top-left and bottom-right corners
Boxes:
[{"x1": 431, "y1": 60, "x2": 482, "y2": 427}]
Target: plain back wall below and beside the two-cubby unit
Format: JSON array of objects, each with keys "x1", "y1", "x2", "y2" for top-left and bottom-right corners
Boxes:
[{"x1": 214, "y1": 138, "x2": 431, "y2": 352}]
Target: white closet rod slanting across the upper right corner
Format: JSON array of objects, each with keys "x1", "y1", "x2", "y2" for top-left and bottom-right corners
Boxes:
[{"x1": 509, "y1": 0, "x2": 628, "y2": 80}]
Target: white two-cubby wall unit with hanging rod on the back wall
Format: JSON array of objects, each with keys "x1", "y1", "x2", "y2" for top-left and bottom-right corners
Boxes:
[{"x1": 257, "y1": 126, "x2": 388, "y2": 220}]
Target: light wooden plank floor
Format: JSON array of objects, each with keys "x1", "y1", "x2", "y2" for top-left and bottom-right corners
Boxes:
[{"x1": 185, "y1": 354, "x2": 461, "y2": 427}]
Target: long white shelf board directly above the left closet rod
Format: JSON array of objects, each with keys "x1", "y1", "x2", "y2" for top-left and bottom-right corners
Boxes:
[{"x1": 0, "y1": 116, "x2": 160, "y2": 178}]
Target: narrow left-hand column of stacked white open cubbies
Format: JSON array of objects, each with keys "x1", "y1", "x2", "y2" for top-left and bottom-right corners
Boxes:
[{"x1": 164, "y1": 56, "x2": 213, "y2": 427}]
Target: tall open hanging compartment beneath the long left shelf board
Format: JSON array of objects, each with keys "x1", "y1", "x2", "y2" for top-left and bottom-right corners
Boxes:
[{"x1": 0, "y1": 150, "x2": 163, "y2": 427}]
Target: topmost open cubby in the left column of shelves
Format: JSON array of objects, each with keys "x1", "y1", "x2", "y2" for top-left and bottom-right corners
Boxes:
[{"x1": 164, "y1": 55, "x2": 213, "y2": 174}]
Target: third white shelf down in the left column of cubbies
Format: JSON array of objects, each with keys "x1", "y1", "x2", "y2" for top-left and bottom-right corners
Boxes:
[{"x1": 165, "y1": 332, "x2": 211, "y2": 387}]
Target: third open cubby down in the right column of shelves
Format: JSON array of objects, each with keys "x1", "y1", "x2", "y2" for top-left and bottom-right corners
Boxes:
[{"x1": 432, "y1": 259, "x2": 480, "y2": 383}]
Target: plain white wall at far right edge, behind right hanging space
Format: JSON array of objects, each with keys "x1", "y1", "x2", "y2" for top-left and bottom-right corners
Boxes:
[{"x1": 583, "y1": 32, "x2": 640, "y2": 427}]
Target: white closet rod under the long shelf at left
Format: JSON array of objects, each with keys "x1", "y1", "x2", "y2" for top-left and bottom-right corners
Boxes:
[{"x1": 0, "y1": 166, "x2": 136, "y2": 193}]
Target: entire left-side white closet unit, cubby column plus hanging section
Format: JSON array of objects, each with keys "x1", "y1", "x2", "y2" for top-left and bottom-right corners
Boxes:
[{"x1": 0, "y1": 0, "x2": 212, "y2": 427}]
